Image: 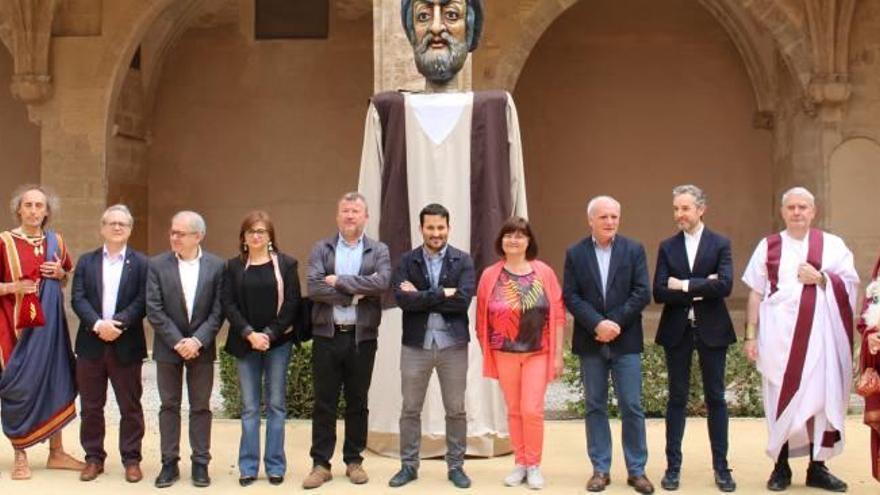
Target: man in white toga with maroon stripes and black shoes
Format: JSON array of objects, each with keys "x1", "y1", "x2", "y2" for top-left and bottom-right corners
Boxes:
[{"x1": 743, "y1": 187, "x2": 859, "y2": 492}]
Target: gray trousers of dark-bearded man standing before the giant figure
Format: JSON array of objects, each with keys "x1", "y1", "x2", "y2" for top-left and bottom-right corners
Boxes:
[{"x1": 400, "y1": 344, "x2": 468, "y2": 469}]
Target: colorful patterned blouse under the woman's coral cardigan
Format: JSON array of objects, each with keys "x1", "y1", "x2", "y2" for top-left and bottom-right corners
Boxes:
[{"x1": 489, "y1": 269, "x2": 550, "y2": 352}]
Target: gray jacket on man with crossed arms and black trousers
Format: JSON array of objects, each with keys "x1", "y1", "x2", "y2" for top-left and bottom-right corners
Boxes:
[{"x1": 308, "y1": 234, "x2": 391, "y2": 342}]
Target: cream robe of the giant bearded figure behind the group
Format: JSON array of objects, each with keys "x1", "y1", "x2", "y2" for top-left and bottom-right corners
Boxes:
[{"x1": 358, "y1": 92, "x2": 527, "y2": 457}]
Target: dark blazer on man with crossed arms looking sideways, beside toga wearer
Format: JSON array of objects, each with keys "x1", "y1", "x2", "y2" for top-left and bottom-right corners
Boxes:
[{"x1": 654, "y1": 227, "x2": 736, "y2": 347}]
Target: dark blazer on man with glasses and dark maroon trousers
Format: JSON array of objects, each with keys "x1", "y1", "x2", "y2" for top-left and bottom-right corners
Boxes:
[{"x1": 71, "y1": 246, "x2": 148, "y2": 364}]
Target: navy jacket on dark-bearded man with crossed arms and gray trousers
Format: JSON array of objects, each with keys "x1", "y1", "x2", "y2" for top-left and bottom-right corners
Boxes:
[{"x1": 391, "y1": 245, "x2": 477, "y2": 347}]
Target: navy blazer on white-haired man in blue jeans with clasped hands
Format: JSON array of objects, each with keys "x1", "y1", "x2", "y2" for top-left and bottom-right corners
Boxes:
[{"x1": 562, "y1": 234, "x2": 651, "y2": 355}]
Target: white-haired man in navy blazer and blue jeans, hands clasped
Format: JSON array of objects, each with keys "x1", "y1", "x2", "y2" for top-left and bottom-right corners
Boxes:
[{"x1": 563, "y1": 196, "x2": 654, "y2": 493}]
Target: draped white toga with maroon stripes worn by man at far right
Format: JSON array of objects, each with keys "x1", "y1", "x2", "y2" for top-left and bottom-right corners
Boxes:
[{"x1": 742, "y1": 231, "x2": 859, "y2": 460}]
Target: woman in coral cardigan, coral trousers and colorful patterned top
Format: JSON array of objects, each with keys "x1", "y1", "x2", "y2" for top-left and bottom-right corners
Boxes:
[{"x1": 477, "y1": 217, "x2": 565, "y2": 489}]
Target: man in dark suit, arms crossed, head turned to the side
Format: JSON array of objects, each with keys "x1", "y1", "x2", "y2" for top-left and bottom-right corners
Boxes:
[{"x1": 654, "y1": 185, "x2": 736, "y2": 492}]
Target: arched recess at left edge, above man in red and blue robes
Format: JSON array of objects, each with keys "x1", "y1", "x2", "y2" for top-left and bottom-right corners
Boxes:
[{"x1": 0, "y1": 44, "x2": 40, "y2": 208}]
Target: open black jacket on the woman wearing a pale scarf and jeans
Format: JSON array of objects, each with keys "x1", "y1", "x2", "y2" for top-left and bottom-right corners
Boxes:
[{"x1": 220, "y1": 253, "x2": 301, "y2": 357}]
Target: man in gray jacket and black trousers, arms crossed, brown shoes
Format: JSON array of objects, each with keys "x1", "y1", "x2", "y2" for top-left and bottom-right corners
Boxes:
[{"x1": 303, "y1": 193, "x2": 391, "y2": 489}]
